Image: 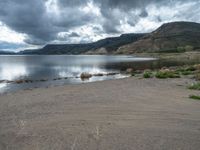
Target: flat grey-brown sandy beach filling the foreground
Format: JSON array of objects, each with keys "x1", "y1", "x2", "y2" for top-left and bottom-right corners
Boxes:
[{"x1": 0, "y1": 78, "x2": 200, "y2": 150}]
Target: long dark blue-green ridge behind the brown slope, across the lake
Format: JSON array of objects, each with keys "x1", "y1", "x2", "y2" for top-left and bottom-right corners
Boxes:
[{"x1": 20, "y1": 34, "x2": 146, "y2": 55}]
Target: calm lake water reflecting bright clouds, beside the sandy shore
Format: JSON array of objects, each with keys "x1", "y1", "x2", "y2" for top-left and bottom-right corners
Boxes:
[{"x1": 0, "y1": 55, "x2": 154, "y2": 93}]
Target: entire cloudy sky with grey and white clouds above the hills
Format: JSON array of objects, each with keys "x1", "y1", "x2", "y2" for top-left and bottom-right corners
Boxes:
[{"x1": 0, "y1": 0, "x2": 200, "y2": 51}]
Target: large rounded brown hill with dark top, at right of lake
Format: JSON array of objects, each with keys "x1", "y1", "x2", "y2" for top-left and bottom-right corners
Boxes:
[{"x1": 117, "y1": 22, "x2": 200, "y2": 54}]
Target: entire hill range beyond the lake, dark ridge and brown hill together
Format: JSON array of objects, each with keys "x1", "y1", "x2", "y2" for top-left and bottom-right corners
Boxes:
[{"x1": 15, "y1": 22, "x2": 200, "y2": 55}]
